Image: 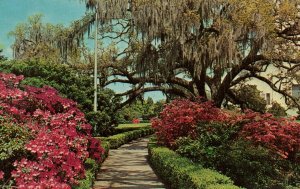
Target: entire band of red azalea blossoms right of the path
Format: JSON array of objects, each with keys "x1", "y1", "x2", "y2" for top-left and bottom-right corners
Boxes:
[{"x1": 152, "y1": 99, "x2": 300, "y2": 162}]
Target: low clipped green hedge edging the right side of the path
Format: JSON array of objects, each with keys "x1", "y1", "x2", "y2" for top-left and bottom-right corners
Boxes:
[{"x1": 148, "y1": 143, "x2": 239, "y2": 189}]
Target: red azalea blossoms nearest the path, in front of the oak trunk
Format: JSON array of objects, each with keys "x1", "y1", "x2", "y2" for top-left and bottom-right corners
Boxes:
[{"x1": 152, "y1": 99, "x2": 228, "y2": 147}]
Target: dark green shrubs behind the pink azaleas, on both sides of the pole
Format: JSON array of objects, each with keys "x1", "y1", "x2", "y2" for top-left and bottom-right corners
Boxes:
[{"x1": 0, "y1": 61, "x2": 121, "y2": 136}]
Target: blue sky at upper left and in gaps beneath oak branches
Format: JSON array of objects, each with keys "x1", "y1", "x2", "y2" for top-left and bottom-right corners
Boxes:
[{"x1": 0, "y1": 0, "x2": 164, "y2": 101}]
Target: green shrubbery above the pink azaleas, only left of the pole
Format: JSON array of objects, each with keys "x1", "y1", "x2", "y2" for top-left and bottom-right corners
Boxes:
[{"x1": 0, "y1": 61, "x2": 93, "y2": 111}]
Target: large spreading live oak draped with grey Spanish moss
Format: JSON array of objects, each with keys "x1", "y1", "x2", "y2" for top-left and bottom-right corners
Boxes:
[{"x1": 75, "y1": 0, "x2": 300, "y2": 108}]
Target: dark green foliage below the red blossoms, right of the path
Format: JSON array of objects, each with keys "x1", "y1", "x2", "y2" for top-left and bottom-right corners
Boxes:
[{"x1": 176, "y1": 122, "x2": 300, "y2": 189}]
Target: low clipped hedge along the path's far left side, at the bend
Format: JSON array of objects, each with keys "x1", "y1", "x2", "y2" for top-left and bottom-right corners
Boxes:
[{"x1": 96, "y1": 127, "x2": 154, "y2": 149}]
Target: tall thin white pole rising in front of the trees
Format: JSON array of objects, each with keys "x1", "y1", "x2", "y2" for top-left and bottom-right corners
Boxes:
[{"x1": 94, "y1": 5, "x2": 98, "y2": 112}]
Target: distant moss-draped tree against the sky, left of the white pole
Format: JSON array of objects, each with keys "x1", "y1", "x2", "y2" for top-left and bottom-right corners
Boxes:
[{"x1": 9, "y1": 14, "x2": 86, "y2": 63}]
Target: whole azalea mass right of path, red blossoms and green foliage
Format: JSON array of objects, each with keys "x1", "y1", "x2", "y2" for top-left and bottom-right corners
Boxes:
[{"x1": 152, "y1": 100, "x2": 300, "y2": 189}]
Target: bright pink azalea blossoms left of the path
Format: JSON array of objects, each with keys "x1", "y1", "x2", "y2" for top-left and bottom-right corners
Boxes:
[{"x1": 0, "y1": 73, "x2": 104, "y2": 188}]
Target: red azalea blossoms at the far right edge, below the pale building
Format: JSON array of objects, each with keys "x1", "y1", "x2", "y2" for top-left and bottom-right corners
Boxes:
[{"x1": 240, "y1": 111, "x2": 300, "y2": 161}]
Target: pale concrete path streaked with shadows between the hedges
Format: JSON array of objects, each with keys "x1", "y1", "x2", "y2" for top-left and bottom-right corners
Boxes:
[{"x1": 94, "y1": 139, "x2": 165, "y2": 189}]
